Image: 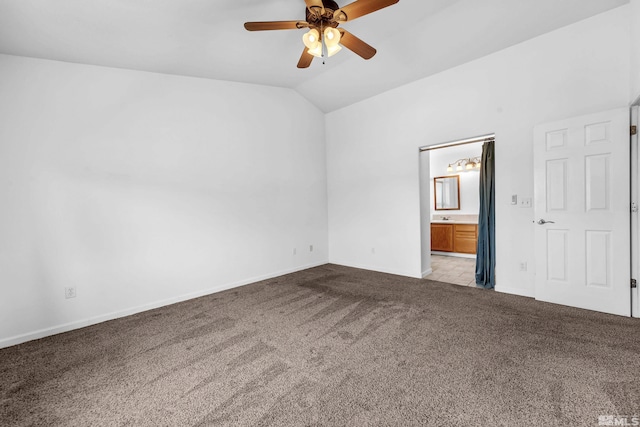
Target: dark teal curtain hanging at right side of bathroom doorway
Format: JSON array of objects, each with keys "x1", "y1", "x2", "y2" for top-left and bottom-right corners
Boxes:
[{"x1": 476, "y1": 140, "x2": 496, "y2": 289}]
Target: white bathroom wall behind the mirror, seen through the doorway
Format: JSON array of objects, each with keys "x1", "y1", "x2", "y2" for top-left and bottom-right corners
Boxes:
[{"x1": 429, "y1": 143, "x2": 482, "y2": 215}]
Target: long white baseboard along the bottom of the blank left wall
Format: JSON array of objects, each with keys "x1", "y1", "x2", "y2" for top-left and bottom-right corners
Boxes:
[{"x1": 0, "y1": 261, "x2": 327, "y2": 348}]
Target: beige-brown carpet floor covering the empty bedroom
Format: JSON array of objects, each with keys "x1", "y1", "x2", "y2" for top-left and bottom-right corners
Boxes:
[{"x1": 0, "y1": 265, "x2": 640, "y2": 426}]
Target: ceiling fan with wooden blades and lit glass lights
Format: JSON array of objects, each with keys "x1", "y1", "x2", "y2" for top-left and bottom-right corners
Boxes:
[{"x1": 244, "y1": 0, "x2": 399, "y2": 68}]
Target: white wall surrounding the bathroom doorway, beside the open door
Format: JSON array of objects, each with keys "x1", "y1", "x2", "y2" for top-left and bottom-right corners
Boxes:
[{"x1": 326, "y1": 5, "x2": 630, "y2": 295}]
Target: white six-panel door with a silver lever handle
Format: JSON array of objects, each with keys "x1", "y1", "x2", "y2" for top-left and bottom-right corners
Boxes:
[{"x1": 534, "y1": 108, "x2": 631, "y2": 316}]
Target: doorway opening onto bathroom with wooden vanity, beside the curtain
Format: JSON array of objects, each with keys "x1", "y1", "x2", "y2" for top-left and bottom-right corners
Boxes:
[{"x1": 420, "y1": 134, "x2": 495, "y2": 287}]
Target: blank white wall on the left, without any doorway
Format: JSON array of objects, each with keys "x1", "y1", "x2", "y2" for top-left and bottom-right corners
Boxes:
[{"x1": 0, "y1": 56, "x2": 327, "y2": 346}]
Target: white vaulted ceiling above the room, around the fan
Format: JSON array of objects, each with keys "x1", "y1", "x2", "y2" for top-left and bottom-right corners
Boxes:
[{"x1": 0, "y1": 0, "x2": 629, "y2": 112}]
